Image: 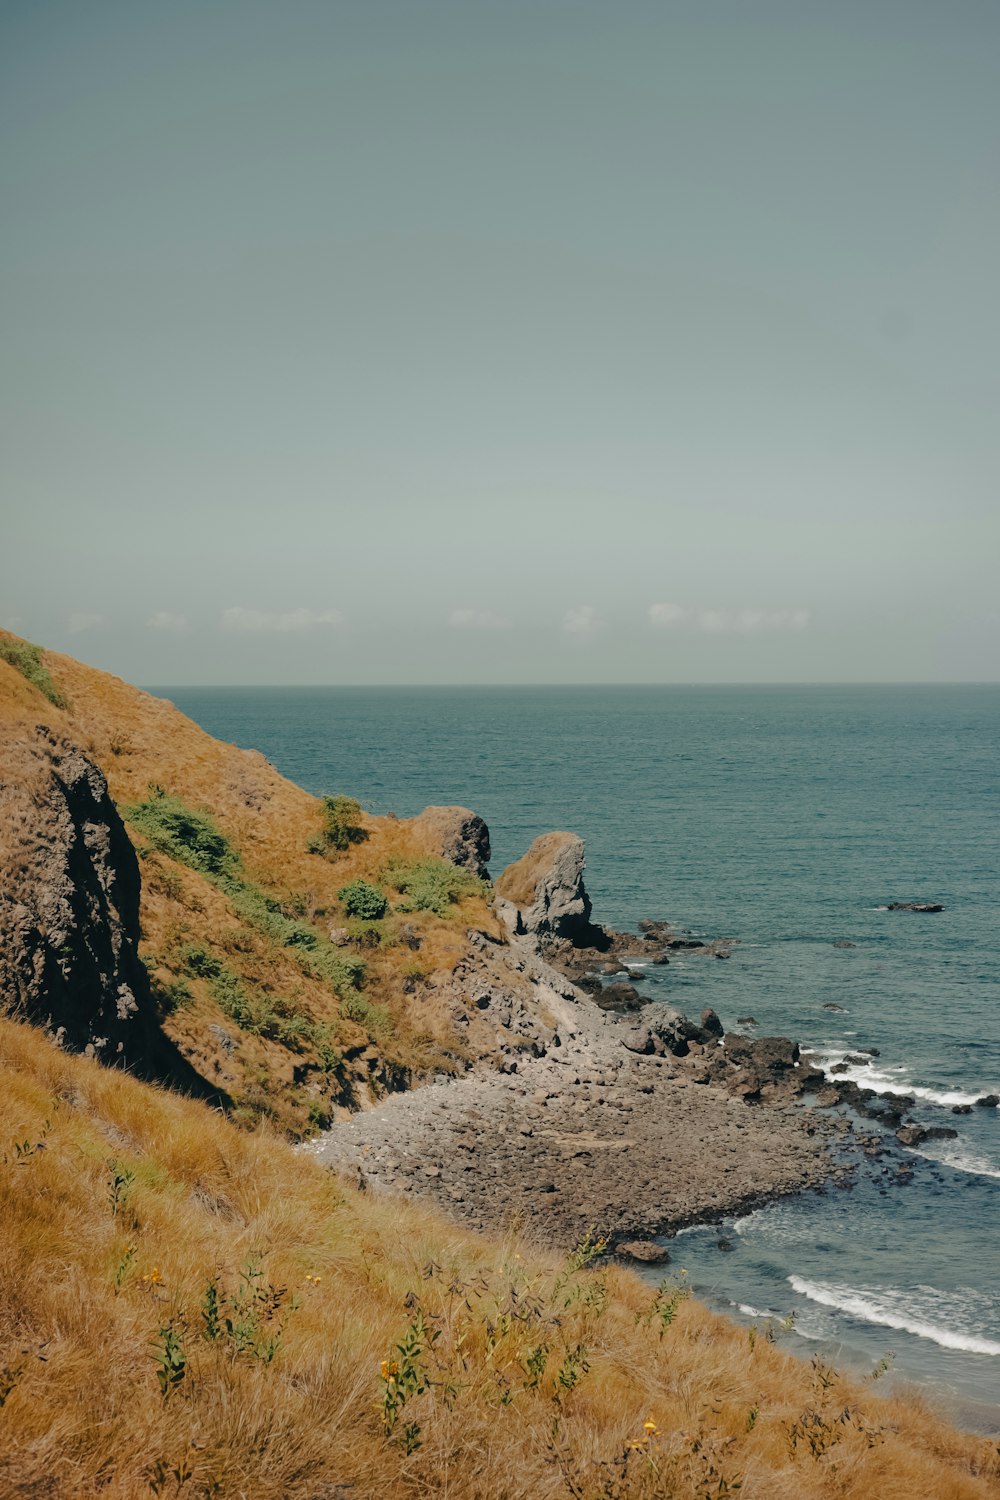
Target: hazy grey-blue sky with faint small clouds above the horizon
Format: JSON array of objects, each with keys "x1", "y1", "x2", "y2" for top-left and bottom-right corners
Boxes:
[{"x1": 0, "y1": 0, "x2": 1000, "y2": 684}]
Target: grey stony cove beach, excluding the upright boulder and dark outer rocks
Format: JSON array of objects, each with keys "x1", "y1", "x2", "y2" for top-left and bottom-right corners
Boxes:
[{"x1": 313, "y1": 935, "x2": 849, "y2": 1248}]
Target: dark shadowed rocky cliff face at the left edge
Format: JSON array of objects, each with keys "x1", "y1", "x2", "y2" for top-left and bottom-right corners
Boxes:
[{"x1": 0, "y1": 726, "x2": 153, "y2": 1059}]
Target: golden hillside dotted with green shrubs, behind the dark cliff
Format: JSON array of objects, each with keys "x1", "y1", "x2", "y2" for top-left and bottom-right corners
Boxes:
[{"x1": 0, "y1": 633, "x2": 498, "y2": 1136}]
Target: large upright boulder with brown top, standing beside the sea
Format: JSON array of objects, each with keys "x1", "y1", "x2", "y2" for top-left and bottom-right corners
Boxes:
[{"x1": 496, "y1": 833, "x2": 603, "y2": 948}]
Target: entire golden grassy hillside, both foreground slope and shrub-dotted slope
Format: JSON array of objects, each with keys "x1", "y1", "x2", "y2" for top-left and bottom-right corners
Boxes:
[{"x1": 0, "y1": 635, "x2": 1000, "y2": 1500}]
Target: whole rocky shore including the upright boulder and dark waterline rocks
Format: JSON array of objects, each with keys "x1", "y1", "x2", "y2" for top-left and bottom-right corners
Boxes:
[{"x1": 313, "y1": 833, "x2": 959, "y2": 1260}]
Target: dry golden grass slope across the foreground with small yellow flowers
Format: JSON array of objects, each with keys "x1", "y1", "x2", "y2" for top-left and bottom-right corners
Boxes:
[{"x1": 0, "y1": 1022, "x2": 1000, "y2": 1500}]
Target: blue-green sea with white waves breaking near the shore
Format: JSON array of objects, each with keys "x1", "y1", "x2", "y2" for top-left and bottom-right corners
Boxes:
[{"x1": 157, "y1": 686, "x2": 1000, "y2": 1428}]
